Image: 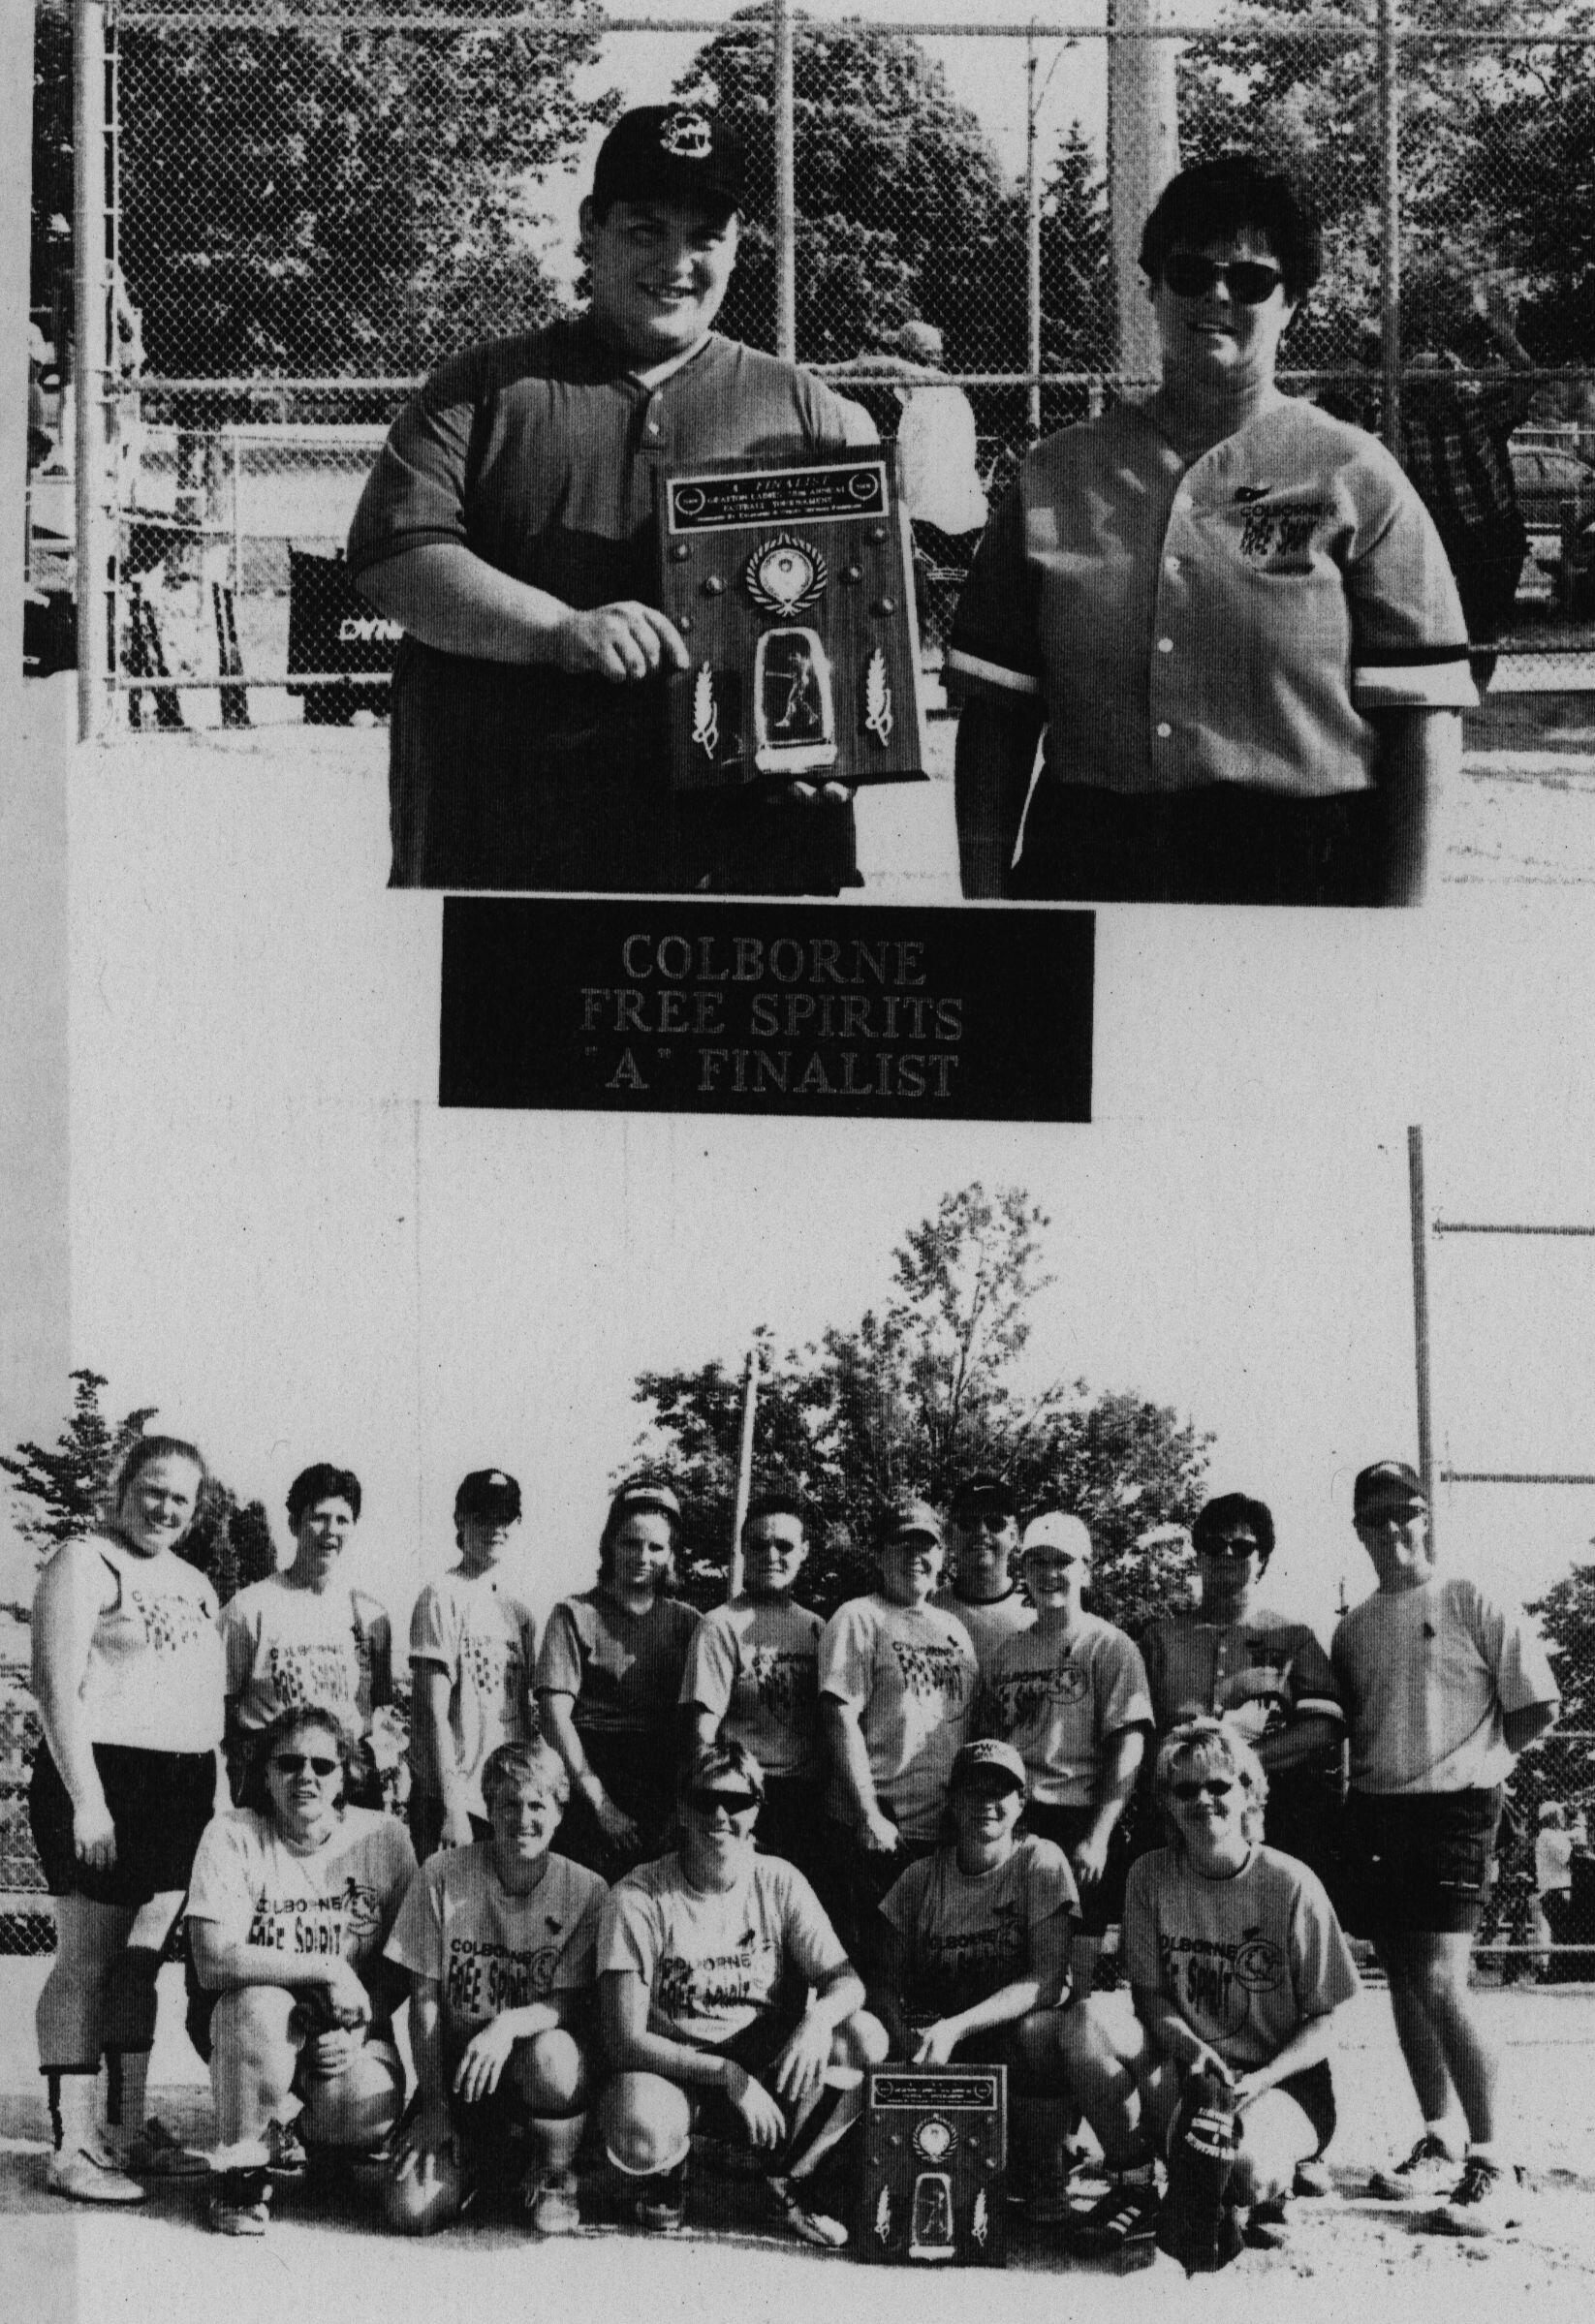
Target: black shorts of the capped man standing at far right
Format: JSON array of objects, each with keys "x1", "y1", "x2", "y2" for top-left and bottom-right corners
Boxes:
[{"x1": 1341, "y1": 1787, "x2": 1502, "y2": 1940}]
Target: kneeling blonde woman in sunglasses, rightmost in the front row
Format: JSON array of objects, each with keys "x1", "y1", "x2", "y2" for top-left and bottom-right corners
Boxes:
[{"x1": 1065, "y1": 1718, "x2": 1358, "y2": 2245}]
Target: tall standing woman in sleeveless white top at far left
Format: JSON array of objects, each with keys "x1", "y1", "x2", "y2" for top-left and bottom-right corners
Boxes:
[{"x1": 28, "y1": 1437, "x2": 228, "y2": 2203}]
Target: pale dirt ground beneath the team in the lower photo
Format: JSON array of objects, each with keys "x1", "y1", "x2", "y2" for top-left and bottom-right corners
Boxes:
[{"x1": 0, "y1": 1959, "x2": 1595, "y2": 2324}]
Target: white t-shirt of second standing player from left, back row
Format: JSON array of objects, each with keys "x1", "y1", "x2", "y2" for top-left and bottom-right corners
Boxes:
[{"x1": 221, "y1": 1573, "x2": 384, "y2": 1736}]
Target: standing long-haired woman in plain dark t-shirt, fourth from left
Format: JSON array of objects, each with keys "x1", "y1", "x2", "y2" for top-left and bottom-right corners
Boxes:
[{"x1": 537, "y1": 1478, "x2": 698, "y2": 1880}]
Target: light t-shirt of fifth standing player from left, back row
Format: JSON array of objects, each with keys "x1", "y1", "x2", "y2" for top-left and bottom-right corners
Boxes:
[{"x1": 681, "y1": 1596, "x2": 826, "y2": 1781}]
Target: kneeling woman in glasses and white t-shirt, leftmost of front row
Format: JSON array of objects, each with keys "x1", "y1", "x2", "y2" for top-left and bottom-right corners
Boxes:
[{"x1": 188, "y1": 1708, "x2": 416, "y2": 2236}]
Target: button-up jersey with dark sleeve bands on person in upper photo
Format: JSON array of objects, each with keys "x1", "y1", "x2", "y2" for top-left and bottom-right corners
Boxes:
[{"x1": 949, "y1": 397, "x2": 1477, "y2": 799}]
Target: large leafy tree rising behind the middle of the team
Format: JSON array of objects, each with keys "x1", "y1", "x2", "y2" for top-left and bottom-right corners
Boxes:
[{"x1": 635, "y1": 1183, "x2": 1211, "y2": 1627}]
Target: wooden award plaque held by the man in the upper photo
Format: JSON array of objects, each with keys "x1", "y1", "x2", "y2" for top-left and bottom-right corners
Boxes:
[{"x1": 658, "y1": 450, "x2": 925, "y2": 790}]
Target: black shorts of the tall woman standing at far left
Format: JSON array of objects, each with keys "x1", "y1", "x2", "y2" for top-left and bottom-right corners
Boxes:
[{"x1": 28, "y1": 1743, "x2": 216, "y2": 1910}]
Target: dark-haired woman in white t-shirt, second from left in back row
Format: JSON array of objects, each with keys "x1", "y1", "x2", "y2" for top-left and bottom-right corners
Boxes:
[{"x1": 221, "y1": 1460, "x2": 393, "y2": 1808}]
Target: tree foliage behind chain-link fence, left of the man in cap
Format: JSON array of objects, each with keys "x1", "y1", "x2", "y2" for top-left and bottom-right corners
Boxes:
[{"x1": 35, "y1": 7, "x2": 616, "y2": 377}]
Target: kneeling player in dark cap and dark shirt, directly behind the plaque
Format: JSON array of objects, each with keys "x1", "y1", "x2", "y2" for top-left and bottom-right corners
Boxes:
[{"x1": 869, "y1": 1741, "x2": 1079, "y2": 2215}]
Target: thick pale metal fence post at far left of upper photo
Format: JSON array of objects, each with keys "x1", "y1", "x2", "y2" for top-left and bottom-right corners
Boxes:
[{"x1": 72, "y1": 0, "x2": 111, "y2": 741}]
